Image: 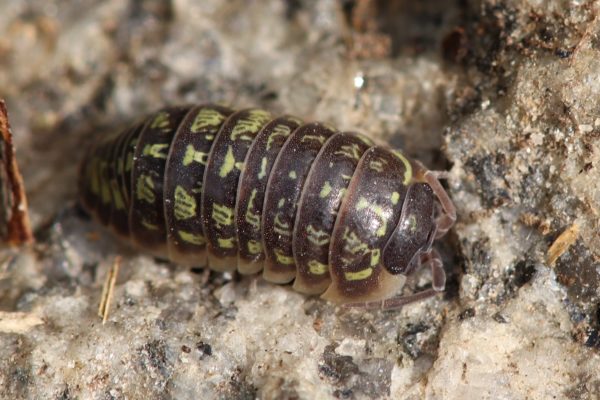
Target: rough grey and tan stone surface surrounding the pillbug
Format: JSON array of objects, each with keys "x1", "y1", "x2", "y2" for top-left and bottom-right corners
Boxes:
[{"x1": 0, "y1": 0, "x2": 600, "y2": 399}]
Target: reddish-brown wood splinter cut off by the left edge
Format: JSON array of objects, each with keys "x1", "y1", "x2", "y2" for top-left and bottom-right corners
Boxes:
[{"x1": 0, "y1": 99, "x2": 33, "y2": 246}]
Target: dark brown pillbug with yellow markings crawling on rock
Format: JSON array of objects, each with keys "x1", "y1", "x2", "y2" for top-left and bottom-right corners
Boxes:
[{"x1": 79, "y1": 105, "x2": 456, "y2": 308}]
